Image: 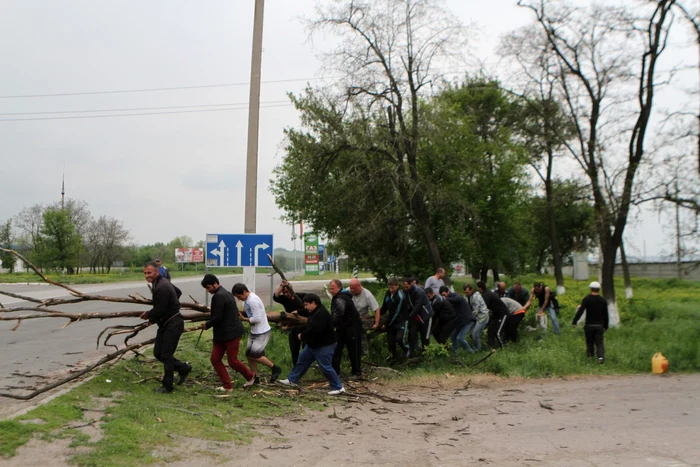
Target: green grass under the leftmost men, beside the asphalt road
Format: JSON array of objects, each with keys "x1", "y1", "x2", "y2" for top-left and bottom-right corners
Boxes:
[{"x1": 0, "y1": 331, "x2": 330, "y2": 466}]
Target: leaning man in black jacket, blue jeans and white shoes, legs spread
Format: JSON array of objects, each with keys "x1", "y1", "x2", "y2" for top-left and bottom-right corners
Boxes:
[{"x1": 279, "y1": 293, "x2": 345, "y2": 396}]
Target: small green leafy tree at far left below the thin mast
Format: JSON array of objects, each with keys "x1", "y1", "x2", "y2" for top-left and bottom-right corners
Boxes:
[{"x1": 38, "y1": 208, "x2": 81, "y2": 274}]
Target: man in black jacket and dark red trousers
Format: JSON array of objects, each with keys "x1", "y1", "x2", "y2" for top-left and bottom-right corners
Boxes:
[{"x1": 202, "y1": 274, "x2": 255, "y2": 392}]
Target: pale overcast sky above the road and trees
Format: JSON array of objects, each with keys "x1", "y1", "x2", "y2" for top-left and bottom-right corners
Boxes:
[{"x1": 0, "y1": 0, "x2": 696, "y2": 262}]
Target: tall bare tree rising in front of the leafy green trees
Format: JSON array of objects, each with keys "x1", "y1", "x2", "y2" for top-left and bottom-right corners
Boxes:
[{"x1": 310, "y1": 0, "x2": 466, "y2": 274}]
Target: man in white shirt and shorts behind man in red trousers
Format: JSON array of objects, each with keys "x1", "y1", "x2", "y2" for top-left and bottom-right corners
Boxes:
[{"x1": 231, "y1": 284, "x2": 282, "y2": 388}]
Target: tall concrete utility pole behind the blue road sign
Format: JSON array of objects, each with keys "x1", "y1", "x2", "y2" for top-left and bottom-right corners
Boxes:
[{"x1": 243, "y1": 0, "x2": 265, "y2": 292}]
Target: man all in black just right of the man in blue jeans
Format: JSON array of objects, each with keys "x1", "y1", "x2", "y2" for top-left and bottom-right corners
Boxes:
[{"x1": 328, "y1": 279, "x2": 362, "y2": 377}]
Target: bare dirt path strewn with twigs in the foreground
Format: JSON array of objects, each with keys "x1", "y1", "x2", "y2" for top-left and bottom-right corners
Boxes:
[{"x1": 5, "y1": 375, "x2": 700, "y2": 467}]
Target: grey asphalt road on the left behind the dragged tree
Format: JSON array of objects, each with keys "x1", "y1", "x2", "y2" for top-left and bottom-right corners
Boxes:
[{"x1": 0, "y1": 274, "x2": 330, "y2": 412}]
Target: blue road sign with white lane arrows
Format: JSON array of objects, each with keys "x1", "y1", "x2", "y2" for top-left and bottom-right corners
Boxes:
[{"x1": 206, "y1": 234, "x2": 274, "y2": 268}]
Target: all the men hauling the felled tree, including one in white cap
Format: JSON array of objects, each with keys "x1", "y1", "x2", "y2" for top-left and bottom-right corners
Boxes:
[{"x1": 141, "y1": 263, "x2": 608, "y2": 394}]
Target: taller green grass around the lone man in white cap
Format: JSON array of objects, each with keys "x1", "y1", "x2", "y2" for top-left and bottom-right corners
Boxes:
[{"x1": 366, "y1": 276, "x2": 700, "y2": 379}]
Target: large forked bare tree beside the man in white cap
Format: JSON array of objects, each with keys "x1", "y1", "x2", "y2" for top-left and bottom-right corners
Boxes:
[{"x1": 518, "y1": 0, "x2": 675, "y2": 326}]
